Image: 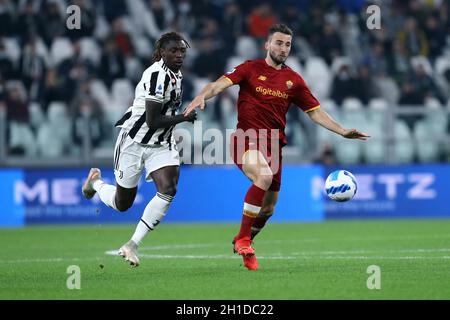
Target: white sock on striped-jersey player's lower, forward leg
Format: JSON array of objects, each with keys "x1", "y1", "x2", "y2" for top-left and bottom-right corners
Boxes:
[{"x1": 131, "y1": 192, "x2": 173, "y2": 245}]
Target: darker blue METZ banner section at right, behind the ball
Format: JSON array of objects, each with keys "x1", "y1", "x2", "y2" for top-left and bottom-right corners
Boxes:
[{"x1": 325, "y1": 165, "x2": 450, "y2": 219}]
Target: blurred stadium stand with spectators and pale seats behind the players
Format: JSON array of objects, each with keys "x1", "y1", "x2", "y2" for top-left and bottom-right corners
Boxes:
[{"x1": 0, "y1": 0, "x2": 450, "y2": 167}]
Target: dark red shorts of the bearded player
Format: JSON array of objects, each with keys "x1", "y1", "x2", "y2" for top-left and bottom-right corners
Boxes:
[{"x1": 230, "y1": 133, "x2": 282, "y2": 192}]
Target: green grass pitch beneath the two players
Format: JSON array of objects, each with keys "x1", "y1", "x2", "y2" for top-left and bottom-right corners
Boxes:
[{"x1": 0, "y1": 220, "x2": 450, "y2": 300}]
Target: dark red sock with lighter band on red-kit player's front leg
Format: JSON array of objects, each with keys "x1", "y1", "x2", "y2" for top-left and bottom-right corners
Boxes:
[{"x1": 236, "y1": 184, "x2": 266, "y2": 239}]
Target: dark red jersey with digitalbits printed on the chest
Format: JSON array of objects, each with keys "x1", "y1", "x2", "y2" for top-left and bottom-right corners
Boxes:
[{"x1": 225, "y1": 59, "x2": 320, "y2": 145}]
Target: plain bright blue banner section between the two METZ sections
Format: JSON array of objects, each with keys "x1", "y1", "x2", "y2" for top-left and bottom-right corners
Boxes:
[{"x1": 171, "y1": 166, "x2": 324, "y2": 221}]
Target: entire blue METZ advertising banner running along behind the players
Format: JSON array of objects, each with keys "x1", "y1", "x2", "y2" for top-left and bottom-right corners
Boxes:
[{"x1": 0, "y1": 165, "x2": 450, "y2": 226}]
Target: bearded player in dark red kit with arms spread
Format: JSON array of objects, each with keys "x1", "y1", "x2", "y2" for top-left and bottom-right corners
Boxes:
[{"x1": 185, "y1": 24, "x2": 369, "y2": 270}]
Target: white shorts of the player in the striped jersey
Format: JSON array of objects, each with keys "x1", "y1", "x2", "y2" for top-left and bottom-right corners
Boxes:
[{"x1": 114, "y1": 130, "x2": 180, "y2": 189}]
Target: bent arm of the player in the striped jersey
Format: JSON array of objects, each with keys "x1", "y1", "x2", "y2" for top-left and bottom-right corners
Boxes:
[{"x1": 145, "y1": 100, "x2": 197, "y2": 130}]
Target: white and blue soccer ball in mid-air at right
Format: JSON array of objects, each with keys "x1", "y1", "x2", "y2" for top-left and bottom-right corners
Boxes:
[{"x1": 325, "y1": 170, "x2": 358, "y2": 202}]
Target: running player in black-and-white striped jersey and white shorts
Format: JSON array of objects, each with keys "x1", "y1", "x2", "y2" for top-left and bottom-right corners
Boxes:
[{"x1": 82, "y1": 32, "x2": 197, "y2": 267}]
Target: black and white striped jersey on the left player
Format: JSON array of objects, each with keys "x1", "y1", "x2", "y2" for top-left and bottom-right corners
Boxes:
[{"x1": 116, "y1": 59, "x2": 182, "y2": 145}]
